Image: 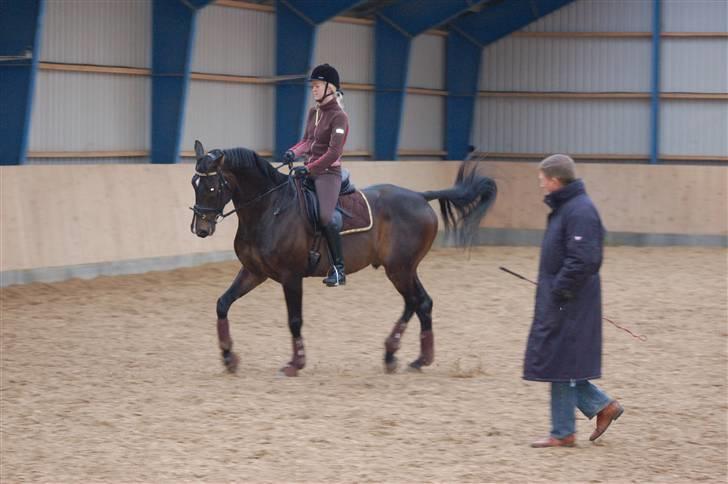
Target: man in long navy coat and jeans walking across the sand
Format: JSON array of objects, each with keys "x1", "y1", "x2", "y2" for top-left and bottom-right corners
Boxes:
[{"x1": 523, "y1": 155, "x2": 624, "y2": 447}]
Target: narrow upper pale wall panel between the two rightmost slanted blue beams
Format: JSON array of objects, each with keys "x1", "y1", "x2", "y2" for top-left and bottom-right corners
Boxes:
[{"x1": 407, "y1": 34, "x2": 447, "y2": 89}]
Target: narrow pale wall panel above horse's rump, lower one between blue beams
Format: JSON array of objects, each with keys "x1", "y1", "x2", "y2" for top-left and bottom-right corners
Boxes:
[{"x1": 399, "y1": 94, "x2": 445, "y2": 150}]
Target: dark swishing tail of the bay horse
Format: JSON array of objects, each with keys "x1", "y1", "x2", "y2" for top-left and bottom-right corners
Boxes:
[{"x1": 422, "y1": 161, "x2": 498, "y2": 247}]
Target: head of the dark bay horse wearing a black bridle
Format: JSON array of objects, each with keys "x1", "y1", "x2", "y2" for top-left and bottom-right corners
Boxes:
[{"x1": 190, "y1": 141, "x2": 233, "y2": 237}]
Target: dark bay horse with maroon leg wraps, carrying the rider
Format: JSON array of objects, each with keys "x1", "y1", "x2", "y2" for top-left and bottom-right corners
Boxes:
[{"x1": 191, "y1": 141, "x2": 496, "y2": 376}]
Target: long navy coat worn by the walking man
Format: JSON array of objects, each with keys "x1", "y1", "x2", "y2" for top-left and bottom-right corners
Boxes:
[{"x1": 523, "y1": 180, "x2": 605, "y2": 382}]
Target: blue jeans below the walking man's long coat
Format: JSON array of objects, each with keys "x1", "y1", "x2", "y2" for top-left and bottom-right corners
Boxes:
[{"x1": 551, "y1": 380, "x2": 612, "y2": 439}]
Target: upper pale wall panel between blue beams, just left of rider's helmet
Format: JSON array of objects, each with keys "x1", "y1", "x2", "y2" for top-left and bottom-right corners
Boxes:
[{"x1": 192, "y1": 5, "x2": 276, "y2": 76}]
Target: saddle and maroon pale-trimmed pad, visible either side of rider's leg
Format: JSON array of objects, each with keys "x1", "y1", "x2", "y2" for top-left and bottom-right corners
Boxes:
[{"x1": 302, "y1": 169, "x2": 373, "y2": 235}]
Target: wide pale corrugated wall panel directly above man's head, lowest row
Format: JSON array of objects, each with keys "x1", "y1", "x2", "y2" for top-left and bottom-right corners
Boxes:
[{"x1": 473, "y1": 98, "x2": 650, "y2": 155}]
